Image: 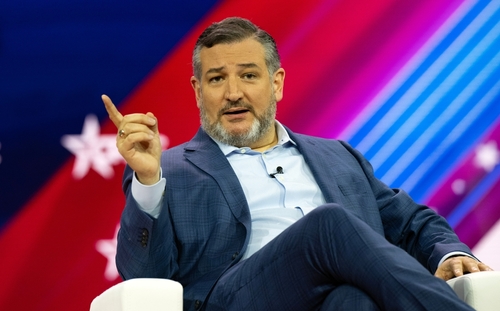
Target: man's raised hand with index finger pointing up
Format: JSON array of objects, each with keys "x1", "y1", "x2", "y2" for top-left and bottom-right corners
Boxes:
[{"x1": 101, "y1": 95, "x2": 161, "y2": 185}]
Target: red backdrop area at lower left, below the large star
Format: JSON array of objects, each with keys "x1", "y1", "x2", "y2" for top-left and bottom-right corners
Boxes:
[{"x1": 0, "y1": 161, "x2": 124, "y2": 310}]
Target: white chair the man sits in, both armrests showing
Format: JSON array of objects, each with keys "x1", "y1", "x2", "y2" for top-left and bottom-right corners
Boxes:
[{"x1": 90, "y1": 271, "x2": 500, "y2": 311}]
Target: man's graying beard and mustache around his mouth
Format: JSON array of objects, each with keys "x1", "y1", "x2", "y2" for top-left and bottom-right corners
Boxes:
[{"x1": 199, "y1": 96, "x2": 276, "y2": 147}]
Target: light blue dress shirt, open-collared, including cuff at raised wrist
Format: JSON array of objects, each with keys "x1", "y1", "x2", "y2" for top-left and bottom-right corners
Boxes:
[{"x1": 132, "y1": 121, "x2": 326, "y2": 258}]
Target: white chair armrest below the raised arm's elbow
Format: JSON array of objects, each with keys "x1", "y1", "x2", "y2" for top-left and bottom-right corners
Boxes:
[{"x1": 90, "y1": 278, "x2": 183, "y2": 311}]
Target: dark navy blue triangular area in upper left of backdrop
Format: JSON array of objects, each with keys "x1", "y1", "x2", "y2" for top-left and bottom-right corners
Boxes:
[{"x1": 0, "y1": 0, "x2": 217, "y2": 229}]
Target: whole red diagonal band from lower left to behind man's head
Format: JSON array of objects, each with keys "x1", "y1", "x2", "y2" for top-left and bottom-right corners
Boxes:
[{"x1": 0, "y1": 1, "x2": 336, "y2": 310}]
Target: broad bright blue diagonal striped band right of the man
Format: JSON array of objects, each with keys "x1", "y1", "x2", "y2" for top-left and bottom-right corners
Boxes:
[{"x1": 347, "y1": 1, "x2": 500, "y2": 200}]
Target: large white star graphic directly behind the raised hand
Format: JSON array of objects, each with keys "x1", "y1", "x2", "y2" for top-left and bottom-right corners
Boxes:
[{"x1": 61, "y1": 114, "x2": 169, "y2": 179}]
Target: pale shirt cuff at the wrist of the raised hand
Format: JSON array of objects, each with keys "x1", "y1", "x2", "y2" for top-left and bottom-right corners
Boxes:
[{"x1": 131, "y1": 169, "x2": 167, "y2": 218}]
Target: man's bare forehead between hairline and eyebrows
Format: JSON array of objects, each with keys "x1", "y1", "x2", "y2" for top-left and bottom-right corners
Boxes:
[{"x1": 200, "y1": 38, "x2": 266, "y2": 73}]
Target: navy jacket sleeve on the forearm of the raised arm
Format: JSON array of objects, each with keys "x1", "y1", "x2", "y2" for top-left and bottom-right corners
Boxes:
[{"x1": 116, "y1": 166, "x2": 178, "y2": 280}]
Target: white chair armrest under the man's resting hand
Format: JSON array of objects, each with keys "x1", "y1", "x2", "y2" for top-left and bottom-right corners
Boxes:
[{"x1": 447, "y1": 271, "x2": 500, "y2": 311}]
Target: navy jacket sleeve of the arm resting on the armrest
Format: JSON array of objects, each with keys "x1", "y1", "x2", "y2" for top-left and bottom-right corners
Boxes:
[{"x1": 342, "y1": 142, "x2": 472, "y2": 273}]
